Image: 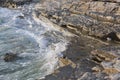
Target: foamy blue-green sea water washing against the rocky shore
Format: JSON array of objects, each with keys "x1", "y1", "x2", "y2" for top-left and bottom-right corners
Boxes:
[{"x1": 0, "y1": 8, "x2": 73, "y2": 80}]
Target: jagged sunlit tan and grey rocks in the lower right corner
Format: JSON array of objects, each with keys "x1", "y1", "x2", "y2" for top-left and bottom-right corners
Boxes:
[{"x1": 92, "y1": 46, "x2": 120, "y2": 80}]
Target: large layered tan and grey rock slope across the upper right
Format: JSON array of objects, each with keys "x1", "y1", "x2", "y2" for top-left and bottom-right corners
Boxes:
[{"x1": 36, "y1": 0, "x2": 120, "y2": 42}]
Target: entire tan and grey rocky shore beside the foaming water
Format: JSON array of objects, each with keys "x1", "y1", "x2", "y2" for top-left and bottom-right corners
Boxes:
[{"x1": 0, "y1": 0, "x2": 120, "y2": 80}]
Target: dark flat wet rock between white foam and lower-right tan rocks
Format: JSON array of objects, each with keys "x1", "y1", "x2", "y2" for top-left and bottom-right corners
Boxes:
[{"x1": 43, "y1": 36, "x2": 109, "y2": 80}]
